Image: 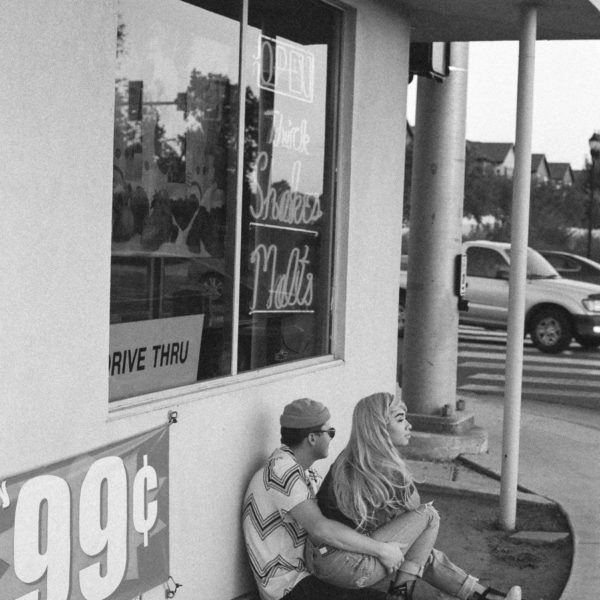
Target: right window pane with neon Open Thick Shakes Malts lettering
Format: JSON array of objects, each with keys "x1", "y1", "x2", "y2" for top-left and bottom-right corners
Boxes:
[{"x1": 238, "y1": 0, "x2": 339, "y2": 370}]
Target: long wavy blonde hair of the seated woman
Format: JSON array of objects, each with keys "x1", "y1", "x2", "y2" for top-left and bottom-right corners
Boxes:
[{"x1": 331, "y1": 392, "x2": 417, "y2": 529}]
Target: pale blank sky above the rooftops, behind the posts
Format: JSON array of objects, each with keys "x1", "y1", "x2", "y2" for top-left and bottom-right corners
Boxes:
[{"x1": 407, "y1": 40, "x2": 600, "y2": 170}]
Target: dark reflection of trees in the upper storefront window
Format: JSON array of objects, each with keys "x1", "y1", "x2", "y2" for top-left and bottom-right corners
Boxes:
[{"x1": 113, "y1": 15, "x2": 259, "y2": 256}]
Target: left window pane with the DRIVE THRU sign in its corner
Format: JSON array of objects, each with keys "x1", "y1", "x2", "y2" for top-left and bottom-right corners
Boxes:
[{"x1": 109, "y1": 0, "x2": 241, "y2": 400}]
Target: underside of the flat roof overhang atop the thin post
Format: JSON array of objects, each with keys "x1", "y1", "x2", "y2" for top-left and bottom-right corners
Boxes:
[{"x1": 395, "y1": 0, "x2": 600, "y2": 42}]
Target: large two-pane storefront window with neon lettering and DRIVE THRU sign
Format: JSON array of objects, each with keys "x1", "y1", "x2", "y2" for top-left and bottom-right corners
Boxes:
[{"x1": 109, "y1": 0, "x2": 339, "y2": 401}]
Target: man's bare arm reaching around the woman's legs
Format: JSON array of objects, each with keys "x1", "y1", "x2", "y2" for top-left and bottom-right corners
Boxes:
[{"x1": 289, "y1": 500, "x2": 406, "y2": 573}]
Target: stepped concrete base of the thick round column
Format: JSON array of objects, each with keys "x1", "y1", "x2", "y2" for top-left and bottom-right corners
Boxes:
[{"x1": 402, "y1": 412, "x2": 488, "y2": 461}]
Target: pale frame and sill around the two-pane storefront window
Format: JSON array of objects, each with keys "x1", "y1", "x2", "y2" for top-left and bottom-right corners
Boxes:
[{"x1": 107, "y1": 0, "x2": 357, "y2": 419}]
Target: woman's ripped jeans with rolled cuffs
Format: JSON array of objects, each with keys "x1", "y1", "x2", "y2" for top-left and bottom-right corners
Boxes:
[{"x1": 304, "y1": 504, "x2": 477, "y2": 600}]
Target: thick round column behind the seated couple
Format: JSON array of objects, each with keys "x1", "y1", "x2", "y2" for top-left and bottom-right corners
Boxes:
[{"x1": 402, "y1": 42, "x2": 469, "y2": 418}]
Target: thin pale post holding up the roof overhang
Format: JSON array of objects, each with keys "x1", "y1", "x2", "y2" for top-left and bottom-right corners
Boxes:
[{"x1": 500, "y1": 6, "x2": 537, "y2": 531}]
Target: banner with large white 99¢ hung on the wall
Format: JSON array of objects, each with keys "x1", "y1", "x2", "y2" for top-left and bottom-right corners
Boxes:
[{"x1": 0, "y1": 426, "x2": 169, "y2": 600}]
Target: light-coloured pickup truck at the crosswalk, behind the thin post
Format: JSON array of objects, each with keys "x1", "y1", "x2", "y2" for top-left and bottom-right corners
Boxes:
[{"x1": 398, "y1": 241, "x2": 600, "y2": 353}]
